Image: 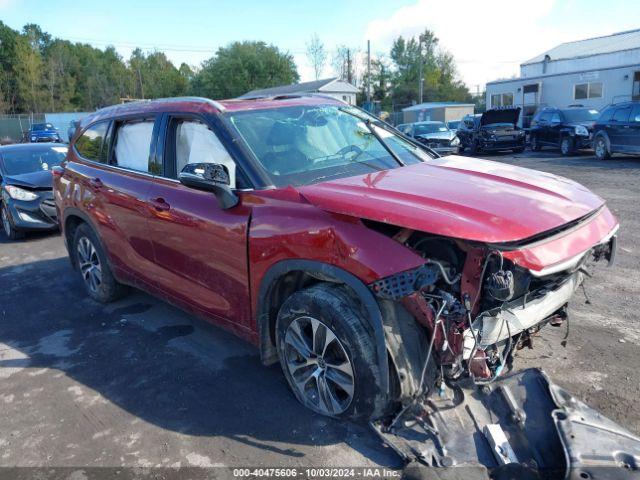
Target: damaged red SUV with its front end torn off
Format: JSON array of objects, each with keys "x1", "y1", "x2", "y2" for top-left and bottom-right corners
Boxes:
[{"x1": 54, "y1": 96, "x2": 618, "y2": 418}]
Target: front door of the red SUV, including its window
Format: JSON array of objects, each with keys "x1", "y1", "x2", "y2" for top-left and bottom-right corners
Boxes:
[{"x1": 147, "y1": 114, "x2": 253, "y2": 334}]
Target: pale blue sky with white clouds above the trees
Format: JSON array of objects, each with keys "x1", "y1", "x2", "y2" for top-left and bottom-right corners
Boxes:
[{"x1": 0, "y1": 0, "x2": 640, "y2": 92}]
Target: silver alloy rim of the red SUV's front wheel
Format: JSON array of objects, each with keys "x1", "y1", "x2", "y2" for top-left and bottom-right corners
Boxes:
[{"x1": 284, "y1": 316, "x2": 354, "y2": 416}]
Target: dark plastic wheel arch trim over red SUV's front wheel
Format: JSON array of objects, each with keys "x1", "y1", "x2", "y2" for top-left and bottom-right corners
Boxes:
[{"x1": 256, "y1": 259, "x2": 389, "y2": 392}]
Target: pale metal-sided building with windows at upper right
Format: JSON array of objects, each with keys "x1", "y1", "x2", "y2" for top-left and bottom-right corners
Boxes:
[{"x1": 487, "y1": 29, "x2": 640, "y2": 127}]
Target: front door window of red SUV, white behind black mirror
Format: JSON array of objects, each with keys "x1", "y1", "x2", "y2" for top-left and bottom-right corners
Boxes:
[{"x1": 175, "y1": 120, "x2": 236, "y2": 188}]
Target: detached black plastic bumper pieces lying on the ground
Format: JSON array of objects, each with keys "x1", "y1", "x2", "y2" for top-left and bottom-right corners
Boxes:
[{"x1": 372, "y1": 369, "x2": 640, "y2": 479}]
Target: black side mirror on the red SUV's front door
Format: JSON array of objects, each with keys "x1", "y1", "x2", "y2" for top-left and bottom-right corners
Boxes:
[{"x1": 178, "y1": 163, "x2": 239, "y2": 210}]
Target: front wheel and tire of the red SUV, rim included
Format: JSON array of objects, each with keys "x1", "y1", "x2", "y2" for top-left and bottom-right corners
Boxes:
[{"x1": 276, "y1": 283, "x2": 388, "y2": 420}]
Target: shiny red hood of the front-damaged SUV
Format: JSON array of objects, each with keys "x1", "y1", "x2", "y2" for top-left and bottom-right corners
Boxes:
[{"x1": 299, "y1": 155, "x2": 604, "y2": 243}]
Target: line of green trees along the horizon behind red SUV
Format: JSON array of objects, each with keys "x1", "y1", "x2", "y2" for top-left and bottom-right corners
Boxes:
[{"x1": 0, "y1": 21, "x2": 472, "y2": 113}]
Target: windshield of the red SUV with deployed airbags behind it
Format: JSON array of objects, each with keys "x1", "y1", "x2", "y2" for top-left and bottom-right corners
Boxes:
[{"x1": 228, "y1": 105, "x2": 432, "y2": 187}]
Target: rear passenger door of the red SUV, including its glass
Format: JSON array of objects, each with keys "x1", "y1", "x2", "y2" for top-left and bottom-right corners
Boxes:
[{"x1": 71, "y1": 116, "x2": 155, "y2": 280}]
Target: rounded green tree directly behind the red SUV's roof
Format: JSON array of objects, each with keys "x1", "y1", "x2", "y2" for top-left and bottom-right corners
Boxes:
[{"x1": 191, "y1": 41, "x2": 300, "y2": 99}]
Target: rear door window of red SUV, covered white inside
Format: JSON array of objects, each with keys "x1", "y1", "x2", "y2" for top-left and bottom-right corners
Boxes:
[{"x1": 113, "y1": 119, "x2": 158, "y2": 173}]
